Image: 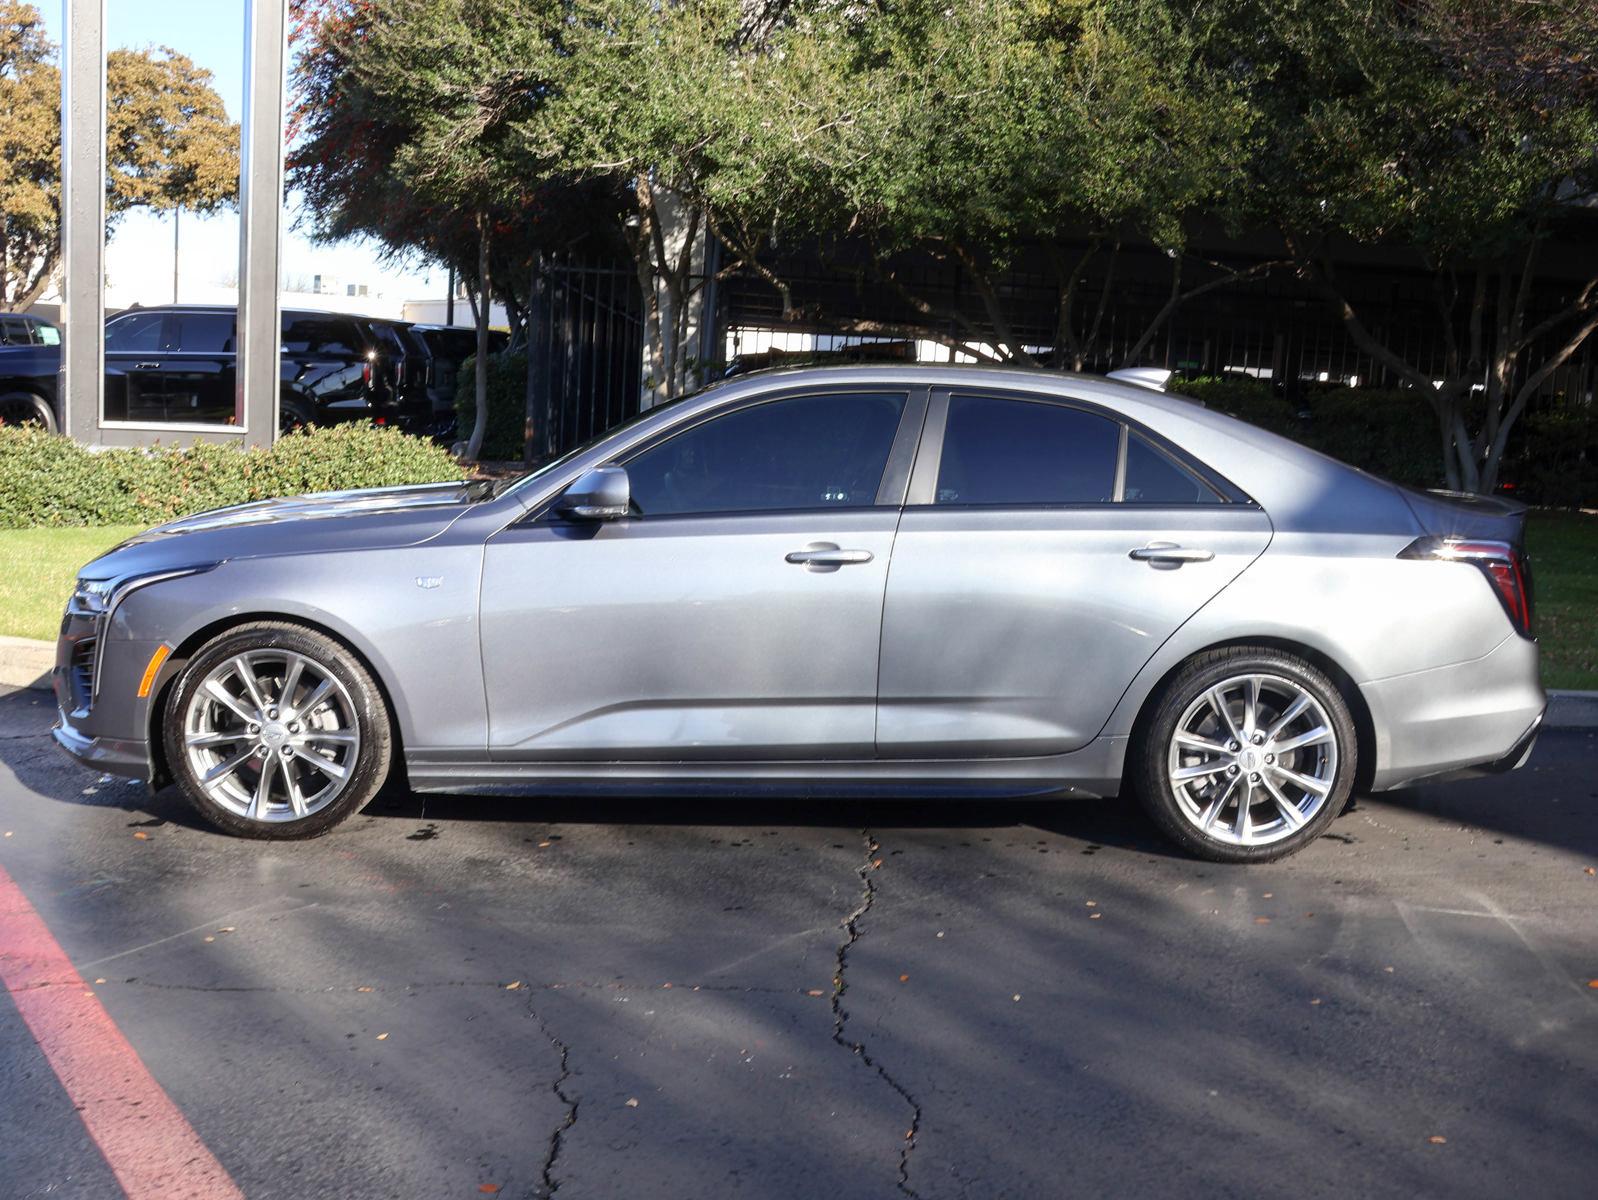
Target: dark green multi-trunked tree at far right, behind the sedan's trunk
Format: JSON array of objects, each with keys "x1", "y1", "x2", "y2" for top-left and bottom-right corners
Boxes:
[{"x1": 1227, "y1": 0, "x2": 1598, "y2": 492}]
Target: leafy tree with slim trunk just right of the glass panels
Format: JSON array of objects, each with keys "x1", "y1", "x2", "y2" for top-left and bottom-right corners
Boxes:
[{"x1": 289, "y1": 0, "x2": 615, "y2": 460}]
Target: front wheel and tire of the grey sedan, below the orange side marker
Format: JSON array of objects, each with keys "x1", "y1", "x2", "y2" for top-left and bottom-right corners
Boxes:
[{"x1": 161, "y1": 622, "x2": 393, "y2": 839}]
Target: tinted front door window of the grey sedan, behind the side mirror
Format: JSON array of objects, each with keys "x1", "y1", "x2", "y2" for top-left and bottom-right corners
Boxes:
[{"x1": 626, "y1": 393, "x2": 904, "y2": 516}]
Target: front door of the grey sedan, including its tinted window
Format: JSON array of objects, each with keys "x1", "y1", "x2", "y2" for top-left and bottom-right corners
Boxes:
[{"x1": 481, "y1": 388, "x2": 925, "y2": 762}]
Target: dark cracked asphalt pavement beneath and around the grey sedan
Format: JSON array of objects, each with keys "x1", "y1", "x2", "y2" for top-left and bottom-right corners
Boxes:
[{"x1": 0, "y1": 692, "x2": 1598, "y2": 1197}]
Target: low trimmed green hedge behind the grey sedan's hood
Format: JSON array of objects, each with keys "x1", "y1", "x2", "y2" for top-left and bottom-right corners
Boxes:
[{"x1": 0, "y1": 425, "x2": 463, "y2": 529}]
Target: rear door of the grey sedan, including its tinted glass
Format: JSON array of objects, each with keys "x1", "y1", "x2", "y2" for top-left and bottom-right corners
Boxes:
[{"x1": 877, "y1": 391, "x2": 1270, "y2": 757}]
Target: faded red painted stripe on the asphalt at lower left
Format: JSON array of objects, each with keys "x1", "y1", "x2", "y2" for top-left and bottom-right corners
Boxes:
[{"x1": 0, "y1": 868, "x2": 244, "y2": 1200}]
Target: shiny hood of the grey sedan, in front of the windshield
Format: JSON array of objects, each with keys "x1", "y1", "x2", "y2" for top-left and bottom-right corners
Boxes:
[{"x1": 81, "y1": 483, "x2": 487, "y2": 578}]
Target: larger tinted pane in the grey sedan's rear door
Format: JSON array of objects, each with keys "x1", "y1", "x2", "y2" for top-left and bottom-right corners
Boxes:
[{"x1": 936, "y1": 396, "x2": 1120, "y2": 505}]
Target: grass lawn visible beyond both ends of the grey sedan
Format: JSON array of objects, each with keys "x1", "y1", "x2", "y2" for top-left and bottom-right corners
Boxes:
[{"x1": 0, "y1": 511, "x2": 1598, "y2": 689}]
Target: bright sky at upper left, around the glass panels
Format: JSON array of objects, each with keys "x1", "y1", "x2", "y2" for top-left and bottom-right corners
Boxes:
[{"x1": 34, "y1": 0, "x2": 446, "y2": 315}]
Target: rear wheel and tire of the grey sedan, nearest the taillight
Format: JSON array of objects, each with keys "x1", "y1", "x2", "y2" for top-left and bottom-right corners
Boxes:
[{"x1": 1130, "y1": 646, "x2": 1360, "y2": 863}]
